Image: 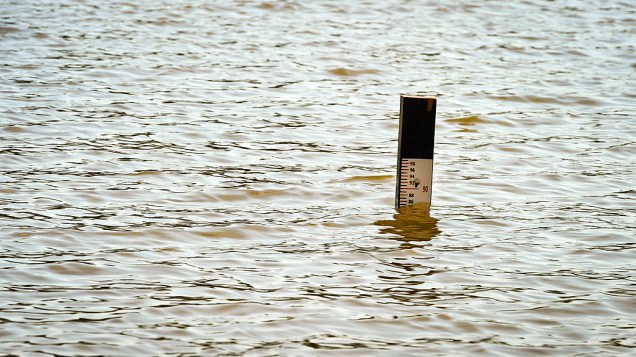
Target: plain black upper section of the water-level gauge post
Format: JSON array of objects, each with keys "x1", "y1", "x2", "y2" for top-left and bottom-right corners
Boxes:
[{"x1": 398, "y1": 95, "x2": 437, "y2": 162}]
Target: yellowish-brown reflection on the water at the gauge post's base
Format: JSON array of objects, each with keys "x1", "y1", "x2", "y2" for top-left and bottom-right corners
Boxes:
[{"x1": 375, "y1": 204, "x2": 440, "y2": 241}]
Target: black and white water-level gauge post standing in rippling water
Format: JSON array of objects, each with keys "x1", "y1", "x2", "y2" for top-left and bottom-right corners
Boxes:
[{"x1": 395, "y1": 95, "x2": 437, "y2": 208}]
